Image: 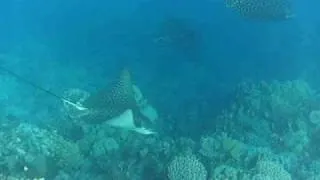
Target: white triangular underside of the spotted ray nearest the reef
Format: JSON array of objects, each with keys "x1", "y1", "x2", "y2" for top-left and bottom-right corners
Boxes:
[{"x1": 106, "y1": 109, "x2": 155, "y2": 135}]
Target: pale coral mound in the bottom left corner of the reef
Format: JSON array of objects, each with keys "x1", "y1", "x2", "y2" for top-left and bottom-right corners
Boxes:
[{"x1": 0, "y1": 123, "x2": 83, "y2": 178}]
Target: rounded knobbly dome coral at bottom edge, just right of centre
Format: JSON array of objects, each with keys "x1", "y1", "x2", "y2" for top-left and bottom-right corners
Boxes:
[{"x1": 168, "y1": 155, "x2": 208, "y2": 180}]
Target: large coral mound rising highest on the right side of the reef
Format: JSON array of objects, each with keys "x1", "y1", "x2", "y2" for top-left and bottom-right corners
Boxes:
[{"x1": 224, "y1": 80, "x2": 314, "y2": 136}]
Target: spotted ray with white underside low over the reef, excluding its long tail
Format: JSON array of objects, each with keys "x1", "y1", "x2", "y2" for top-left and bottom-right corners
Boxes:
[{"x1": 83, "y1": 69, "x2": 154, "y2": 134}]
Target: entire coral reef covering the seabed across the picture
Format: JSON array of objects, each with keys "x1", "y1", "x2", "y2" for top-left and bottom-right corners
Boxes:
[{"x1": 0, "y1": 80, "x2": 320, "y2": 180}]
